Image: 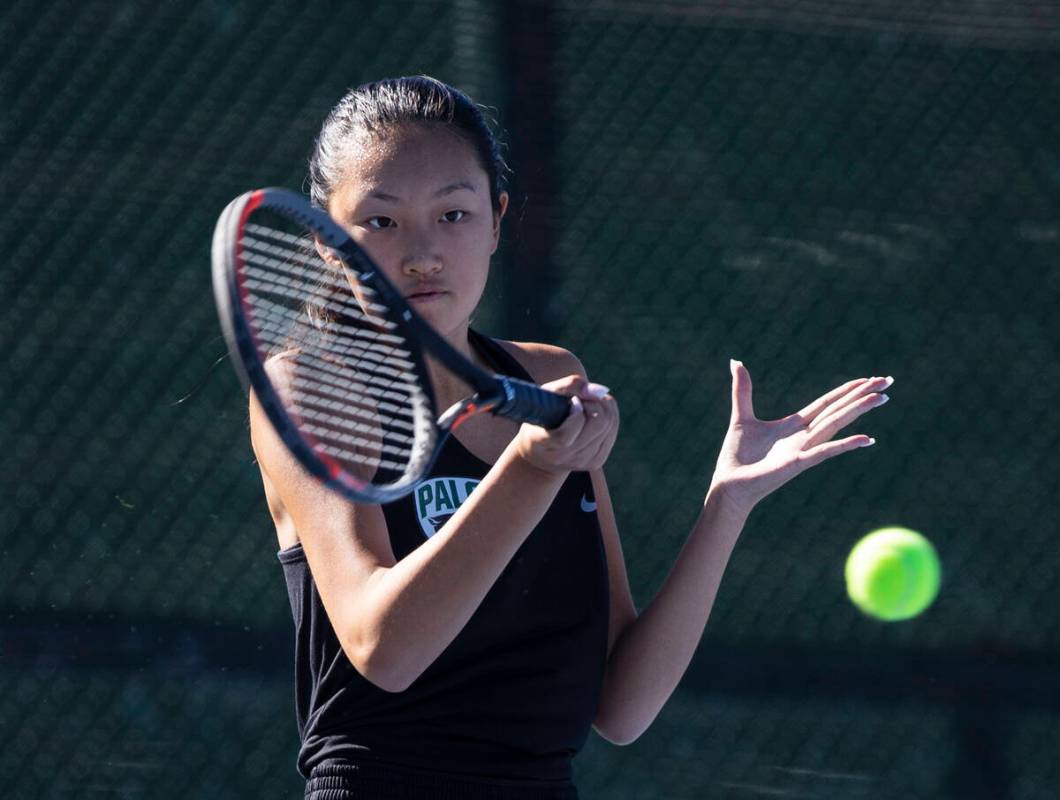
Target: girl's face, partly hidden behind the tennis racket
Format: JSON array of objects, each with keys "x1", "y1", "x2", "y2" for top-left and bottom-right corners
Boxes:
[{"x1": 328, "y1": 125, "x2": 508, "y2": 335}]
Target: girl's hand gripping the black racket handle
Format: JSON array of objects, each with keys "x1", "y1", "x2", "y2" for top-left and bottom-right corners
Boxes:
[{"x1": 513, "y1": 375, "x2": 618, "y2": 473}]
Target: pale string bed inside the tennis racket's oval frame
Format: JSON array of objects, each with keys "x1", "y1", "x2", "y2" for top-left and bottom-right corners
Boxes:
[{"x1": 240, "y1": 216, "x2": 434, "y2": 485}]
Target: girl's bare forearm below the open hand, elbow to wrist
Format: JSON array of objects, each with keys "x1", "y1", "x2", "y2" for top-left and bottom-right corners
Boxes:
[{"x1": 596, "y1": 486, "x2": 749, "y2": 744}]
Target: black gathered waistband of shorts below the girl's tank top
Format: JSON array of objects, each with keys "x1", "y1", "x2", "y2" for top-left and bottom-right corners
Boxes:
[{"x1": 305, "y1": 762, "x2": 578, "y2": 800}]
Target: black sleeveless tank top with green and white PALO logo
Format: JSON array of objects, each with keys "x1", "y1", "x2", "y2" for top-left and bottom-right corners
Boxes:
[{"x1": 278, "y1": 332, "x2": 607, "y2": 781}]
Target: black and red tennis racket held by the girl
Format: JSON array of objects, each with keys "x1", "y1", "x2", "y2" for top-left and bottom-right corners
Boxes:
[{"x1": 212, "y1": 189, "x2": 570, "y2": 503}]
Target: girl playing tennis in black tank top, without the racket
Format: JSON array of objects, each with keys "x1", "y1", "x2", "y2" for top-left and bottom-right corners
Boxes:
[{"x1": 251, "y1": 77, "x2": 889, "y2": 800}]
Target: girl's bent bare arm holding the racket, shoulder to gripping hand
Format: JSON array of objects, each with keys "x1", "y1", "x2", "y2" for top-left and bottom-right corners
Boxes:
[{"x1": 250, "y1": 375, "x2": 618, "y2": 692}]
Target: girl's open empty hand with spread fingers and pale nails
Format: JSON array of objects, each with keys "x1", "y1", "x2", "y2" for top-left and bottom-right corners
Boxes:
[{"x1": 710, "y1": 361, "x2": 894, "y2": 513}]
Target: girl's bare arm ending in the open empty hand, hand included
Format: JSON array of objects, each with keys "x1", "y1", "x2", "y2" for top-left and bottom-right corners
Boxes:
[{"x1": 593, "y1": 361, "x2": 893, "y2": 744}]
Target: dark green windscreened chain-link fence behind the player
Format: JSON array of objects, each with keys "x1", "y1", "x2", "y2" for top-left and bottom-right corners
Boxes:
[{"x1": 0, "y1": 0, "x2": 1060, "y2": 800}]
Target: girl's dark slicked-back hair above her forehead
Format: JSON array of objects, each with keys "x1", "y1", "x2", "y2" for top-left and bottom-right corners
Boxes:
[{"x1": 310, "y1": 75, "x2": 508, "y2": 210}]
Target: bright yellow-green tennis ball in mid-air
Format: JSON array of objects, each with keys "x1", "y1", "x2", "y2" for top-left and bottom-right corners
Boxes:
[{"x1": 846, "y1": 528, "x2": 940, "y2": 622}]
